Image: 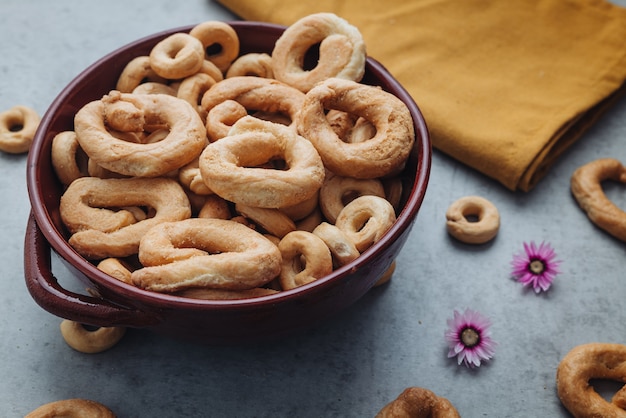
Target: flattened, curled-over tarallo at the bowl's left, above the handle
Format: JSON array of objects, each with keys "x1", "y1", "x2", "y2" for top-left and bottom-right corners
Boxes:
[{"x1": 59, "y1": 177, "x2": 191, "y2": 259}]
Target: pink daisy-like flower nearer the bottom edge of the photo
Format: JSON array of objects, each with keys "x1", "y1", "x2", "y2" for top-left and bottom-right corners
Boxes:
[{"x1": 445, "y1": 309, "x2": 497, "y2": 368}]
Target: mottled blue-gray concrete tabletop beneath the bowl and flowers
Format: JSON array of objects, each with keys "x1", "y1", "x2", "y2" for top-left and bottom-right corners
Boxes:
[{"x1": 0, "y1": 0, "x2": 626, "y2": 417}]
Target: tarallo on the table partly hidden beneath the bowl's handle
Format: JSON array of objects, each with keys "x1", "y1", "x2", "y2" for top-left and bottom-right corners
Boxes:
[{"x1": 60, "y1": 319, "x2": 126, "y2": 354}]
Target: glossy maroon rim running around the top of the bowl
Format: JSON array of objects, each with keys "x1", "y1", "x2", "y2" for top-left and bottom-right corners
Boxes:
[{"x1": 26, "y1": 21, "x2": 432, "y2": 309}]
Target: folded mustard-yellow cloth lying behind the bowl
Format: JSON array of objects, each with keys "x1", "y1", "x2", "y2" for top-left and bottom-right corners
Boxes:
[{"x1": 218, "y1": 0, "x2": 626, "y2": 191}]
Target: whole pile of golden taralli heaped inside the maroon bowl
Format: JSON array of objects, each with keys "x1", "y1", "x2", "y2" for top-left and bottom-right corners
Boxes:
[{"x1": 51, "y1": 13, "x2": 415, "y2": 299}]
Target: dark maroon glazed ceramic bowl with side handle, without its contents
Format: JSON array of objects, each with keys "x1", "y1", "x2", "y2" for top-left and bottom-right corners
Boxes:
[{"x1": 24, "y1": 22, "x2": 431, "y2": 344}]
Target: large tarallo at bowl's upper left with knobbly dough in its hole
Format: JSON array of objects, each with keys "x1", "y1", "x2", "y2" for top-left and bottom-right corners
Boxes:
[{"x1": 74, "y1": 91, "x2": 207, "y2": 177}]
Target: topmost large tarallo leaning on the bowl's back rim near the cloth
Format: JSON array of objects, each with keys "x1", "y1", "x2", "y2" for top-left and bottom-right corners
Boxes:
[{"x1": 272, "y1": 13, "x2": 367, "y2": 92}]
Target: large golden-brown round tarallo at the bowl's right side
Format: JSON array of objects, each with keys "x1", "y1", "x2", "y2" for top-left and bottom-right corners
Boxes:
[{"x1": 297, "y1": 78, "x2": 415, "y2": 178}]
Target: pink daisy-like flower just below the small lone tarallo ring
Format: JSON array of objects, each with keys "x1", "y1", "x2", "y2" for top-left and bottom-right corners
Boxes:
[{"x1": 511, "y1": 241, "x2": 561, "y2": 293}]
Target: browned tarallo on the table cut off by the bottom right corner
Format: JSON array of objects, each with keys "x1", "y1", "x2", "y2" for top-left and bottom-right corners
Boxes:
[{"x1": 556, "y1": 343, "x2": 626, "y2": 418}]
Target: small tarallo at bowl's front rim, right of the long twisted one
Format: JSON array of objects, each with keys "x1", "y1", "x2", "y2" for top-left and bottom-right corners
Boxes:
[{"x1": 278, "y1": 231, "x2": 333, "y2": 290}]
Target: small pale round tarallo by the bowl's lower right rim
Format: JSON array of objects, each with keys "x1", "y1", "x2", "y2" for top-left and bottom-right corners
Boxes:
[{"x1": 335, "y1": 195, "x2": 396, "y2": 253}]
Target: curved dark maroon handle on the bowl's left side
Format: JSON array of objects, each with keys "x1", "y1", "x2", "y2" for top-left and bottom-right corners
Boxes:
[{"x1": 24, "y1": 212, "x2": 161, "y2": 327}]
